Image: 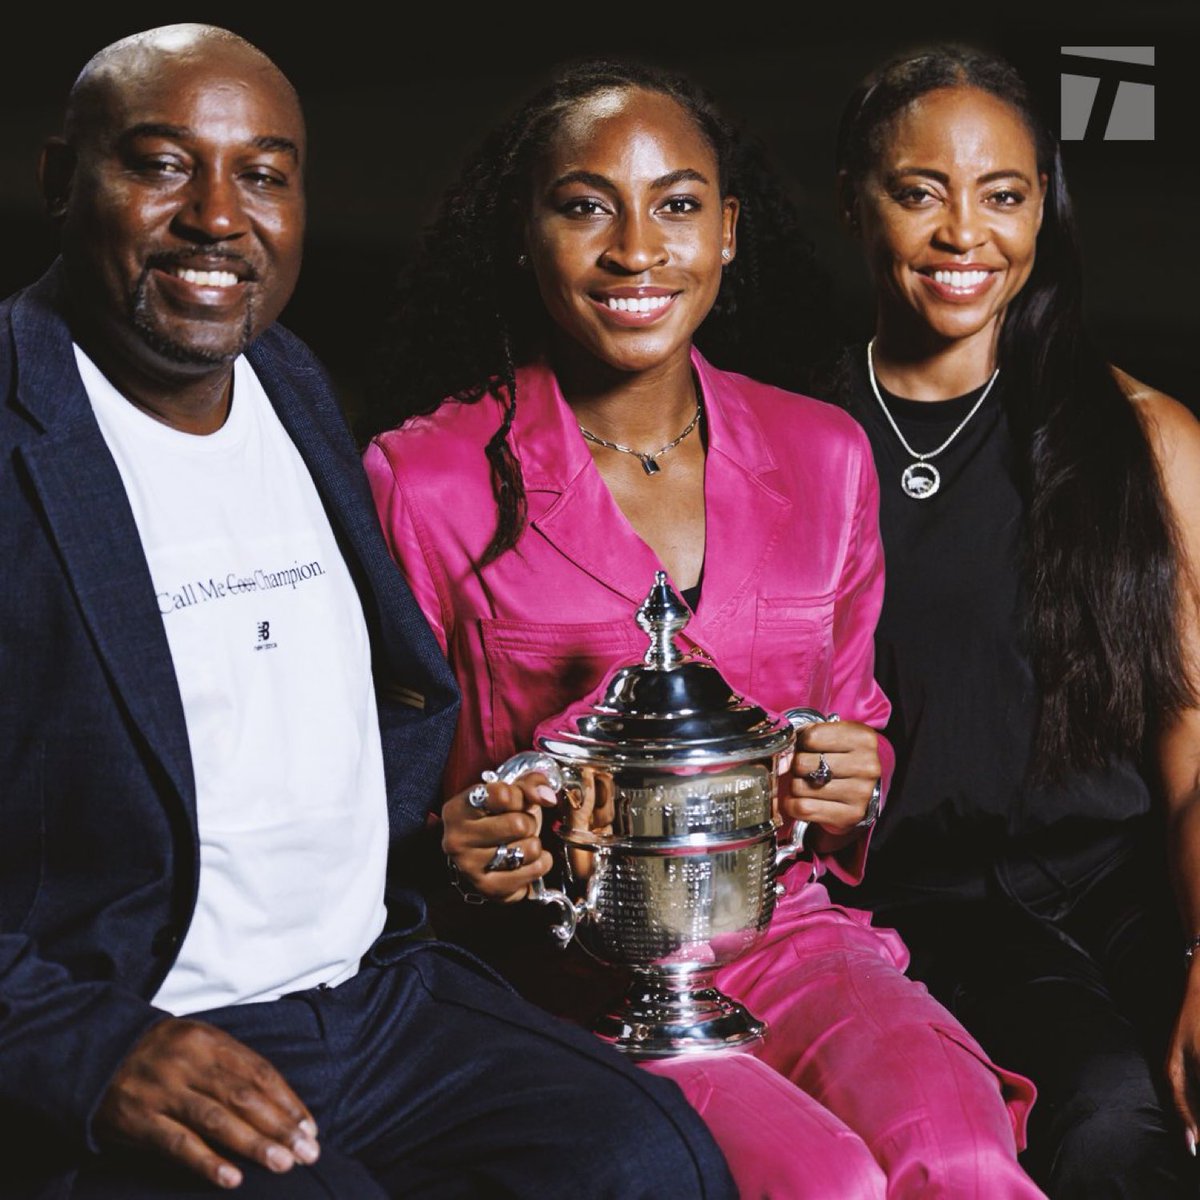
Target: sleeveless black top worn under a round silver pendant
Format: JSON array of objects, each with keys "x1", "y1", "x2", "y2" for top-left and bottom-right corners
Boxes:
[{"x1": 846, "y1": 349, "x2": 1150, "y2": 908}]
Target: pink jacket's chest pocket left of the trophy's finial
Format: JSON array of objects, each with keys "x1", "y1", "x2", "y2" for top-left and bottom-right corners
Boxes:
[{"x1": 480, "y1": 618, "x2": 646, "y2": 762}]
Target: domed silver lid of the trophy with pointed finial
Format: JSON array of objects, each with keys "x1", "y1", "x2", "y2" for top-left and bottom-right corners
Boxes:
[{"x1": 534, "y1": 571, "x2": 792, "y2": 766}]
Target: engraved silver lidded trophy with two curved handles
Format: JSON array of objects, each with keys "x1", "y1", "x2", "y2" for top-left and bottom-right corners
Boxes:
[{"x1": 485, "y1": 571, "x2": 836, "y2": 1058}]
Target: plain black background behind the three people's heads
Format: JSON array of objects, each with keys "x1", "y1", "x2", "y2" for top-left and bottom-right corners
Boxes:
[{"x1": 0, "y1": 0, "x2": 1200, "y2": 417}]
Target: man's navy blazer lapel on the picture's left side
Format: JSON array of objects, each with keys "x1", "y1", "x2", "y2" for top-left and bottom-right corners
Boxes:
[{"x1": 12, "y1": 271, "x2": 196, "y2": 827}]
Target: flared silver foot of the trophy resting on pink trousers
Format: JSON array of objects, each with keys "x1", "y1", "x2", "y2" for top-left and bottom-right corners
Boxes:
[{"x1": 592, "y1": 967, "x2": 767, "y2": 1058}]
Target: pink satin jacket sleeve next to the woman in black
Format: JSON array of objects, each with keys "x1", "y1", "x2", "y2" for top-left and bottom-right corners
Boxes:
[{"x1": 817, "y1": 417, "x2": 895, "y2": 883}]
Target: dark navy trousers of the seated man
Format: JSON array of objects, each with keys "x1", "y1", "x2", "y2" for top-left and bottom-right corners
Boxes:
[{"x1": 56, "y1": 942, "x2": 734, "y2": 1200}]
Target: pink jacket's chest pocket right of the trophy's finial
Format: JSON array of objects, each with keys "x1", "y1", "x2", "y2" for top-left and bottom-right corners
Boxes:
[{"x1": 750, "y1": 592, "x2": 834, "y2": 710}]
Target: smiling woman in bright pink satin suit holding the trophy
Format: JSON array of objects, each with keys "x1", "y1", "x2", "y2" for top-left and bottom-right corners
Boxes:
[{"x1": 366, "y1": 64, "x2": 1039, "y2": 1200}]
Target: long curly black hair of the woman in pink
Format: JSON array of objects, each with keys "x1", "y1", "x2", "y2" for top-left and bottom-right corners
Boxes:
[{"x1": 367, "y1": 60, "x2": 836, "y2": 565}]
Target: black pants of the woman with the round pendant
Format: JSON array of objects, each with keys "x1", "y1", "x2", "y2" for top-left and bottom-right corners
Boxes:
[{"x1": 878, "y1": 835, "x2": 1200, "y2": 1200}]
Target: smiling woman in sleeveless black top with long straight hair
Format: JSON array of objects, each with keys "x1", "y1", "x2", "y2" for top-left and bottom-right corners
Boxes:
[{"x1": 836, "y1": 47, "x2": 1200, "y2": 1200}]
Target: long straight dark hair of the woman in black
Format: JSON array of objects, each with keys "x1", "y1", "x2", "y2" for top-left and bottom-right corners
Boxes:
[{"x1": 838, "y1": 46, "x2": 1193, "y2": 780}]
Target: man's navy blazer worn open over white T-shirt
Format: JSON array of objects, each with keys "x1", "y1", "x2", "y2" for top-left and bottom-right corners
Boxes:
[{"x1": 0, "y1": 264, "x2": 457, "y2": 1180}]
